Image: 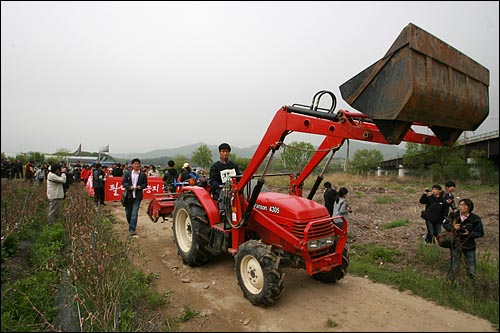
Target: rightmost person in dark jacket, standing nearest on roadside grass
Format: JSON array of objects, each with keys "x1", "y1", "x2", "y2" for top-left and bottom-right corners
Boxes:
[{"x1": 443, "y1": 199, "x2": 484, "y2": 282}]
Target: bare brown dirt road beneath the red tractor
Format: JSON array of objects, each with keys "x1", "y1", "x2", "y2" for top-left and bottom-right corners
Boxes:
[{"x1": 107, "y1": 201, "x2": 495, "y2": 332}]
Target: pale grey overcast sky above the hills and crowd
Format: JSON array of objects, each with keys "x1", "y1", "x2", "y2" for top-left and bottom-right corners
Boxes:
[{"x1": 1, "y1": 1, "x2": 499, "y2": 155}]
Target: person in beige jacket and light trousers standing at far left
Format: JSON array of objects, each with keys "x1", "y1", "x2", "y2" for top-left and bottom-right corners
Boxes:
[{"x1": 47, "y1": 163, "x2": 66, "y2": 225}]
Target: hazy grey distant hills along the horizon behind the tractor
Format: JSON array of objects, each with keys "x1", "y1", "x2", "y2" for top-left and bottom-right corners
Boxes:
[{"x1": 113, "y1": 140, "x2": 405, "y2": 161}]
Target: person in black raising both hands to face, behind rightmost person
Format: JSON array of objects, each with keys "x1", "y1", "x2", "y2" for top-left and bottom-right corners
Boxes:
[{"x1": 419, "y1": 184, "x2": 448, "y2": 244}]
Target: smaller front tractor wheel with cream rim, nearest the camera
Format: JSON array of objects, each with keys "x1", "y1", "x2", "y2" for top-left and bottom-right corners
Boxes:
[{"x1": 235, "y1": 240, "x2": 284, "y2": 306}]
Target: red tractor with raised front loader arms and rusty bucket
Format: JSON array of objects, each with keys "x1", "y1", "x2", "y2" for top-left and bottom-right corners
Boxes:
[{"x1": 172, "y1": 24, "x2": 489, "y2": 306}]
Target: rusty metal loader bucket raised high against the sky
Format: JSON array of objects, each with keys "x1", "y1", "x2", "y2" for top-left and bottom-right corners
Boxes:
[{"x1": 340, "y1": 23, "x2": 490, "y2": 146}]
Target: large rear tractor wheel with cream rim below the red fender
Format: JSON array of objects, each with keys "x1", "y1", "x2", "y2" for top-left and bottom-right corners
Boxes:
[{"x1": 172, "y1": 193, "x2": 213, "y2": 266}]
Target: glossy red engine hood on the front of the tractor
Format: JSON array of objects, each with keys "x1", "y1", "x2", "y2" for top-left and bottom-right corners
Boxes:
[{"x1": 254, "y1": 192, "x2": 328, "y2": 220}]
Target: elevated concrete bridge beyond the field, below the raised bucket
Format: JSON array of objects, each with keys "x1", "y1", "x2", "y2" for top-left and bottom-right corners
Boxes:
[{"x1": 379, "y1": 130, "x2": 499, "y2": 171}]
